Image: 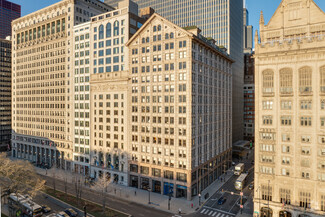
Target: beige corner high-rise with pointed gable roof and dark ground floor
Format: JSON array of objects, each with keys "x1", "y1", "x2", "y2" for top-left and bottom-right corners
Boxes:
[{"x1": 127, "y1": 13, "x2": 233, "y2": 199}]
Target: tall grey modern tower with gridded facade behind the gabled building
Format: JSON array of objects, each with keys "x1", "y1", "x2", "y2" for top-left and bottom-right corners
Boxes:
[{"x1": 105, "y1": 0, "x2": 244, "y2": 142}]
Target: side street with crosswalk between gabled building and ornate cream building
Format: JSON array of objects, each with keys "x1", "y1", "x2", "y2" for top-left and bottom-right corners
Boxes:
[{"x1": 189, "y1": 150, "x2": 254, "y2": 217}]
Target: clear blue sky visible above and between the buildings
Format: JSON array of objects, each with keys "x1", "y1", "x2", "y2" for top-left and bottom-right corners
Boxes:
[{"x1": 9, "y1": 0, "x2": 325, "y2": 35}]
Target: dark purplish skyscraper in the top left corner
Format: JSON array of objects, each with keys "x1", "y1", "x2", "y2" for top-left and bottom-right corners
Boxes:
[{"x1": 0, "y1": 0, "x2": 20, "y2": 39}]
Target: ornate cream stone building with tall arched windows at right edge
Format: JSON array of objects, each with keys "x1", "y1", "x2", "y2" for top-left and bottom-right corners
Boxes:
[{"x1": 254, "y1": 0, "x2": 325, "y2": 217}]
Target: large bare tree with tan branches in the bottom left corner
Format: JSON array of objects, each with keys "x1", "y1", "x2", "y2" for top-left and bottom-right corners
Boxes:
[{"x1": 0, "y1": 154, "x2": 45, "y2": 196}]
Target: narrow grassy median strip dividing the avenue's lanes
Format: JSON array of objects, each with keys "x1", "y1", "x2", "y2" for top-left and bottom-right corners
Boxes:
[{"x1": 44, "y1": 187, "x2": 128, "y2": 217}]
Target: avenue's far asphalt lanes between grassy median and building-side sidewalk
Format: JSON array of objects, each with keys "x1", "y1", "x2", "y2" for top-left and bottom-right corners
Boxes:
[{"x1": 42, "y1": 176, "x2": 172, "y2": 217}]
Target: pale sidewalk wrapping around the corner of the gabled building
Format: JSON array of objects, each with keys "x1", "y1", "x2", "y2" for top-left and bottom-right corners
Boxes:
[{"x1": 36, "y1": 168, "x2": 233, "y2": 214}]
